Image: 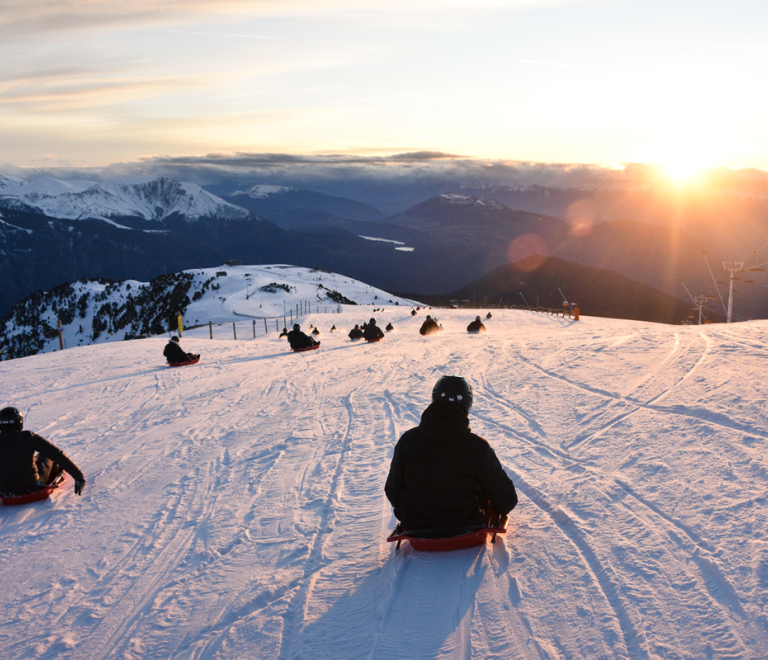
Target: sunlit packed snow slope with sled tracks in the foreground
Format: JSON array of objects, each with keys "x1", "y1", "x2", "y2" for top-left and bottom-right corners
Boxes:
[{"x1": 0, "y1": 306, "x2": 768, "y2": 660}]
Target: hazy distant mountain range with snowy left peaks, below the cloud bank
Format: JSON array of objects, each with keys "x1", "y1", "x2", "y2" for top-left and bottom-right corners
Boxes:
[{"x1": 0, "y1": 171, "x2": 768, "y2": 328}]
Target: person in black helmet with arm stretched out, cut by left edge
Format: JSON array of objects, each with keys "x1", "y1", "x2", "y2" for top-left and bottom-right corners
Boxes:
[{"x1": 0, "y1": 407, "x2": 85, "y2": 496}]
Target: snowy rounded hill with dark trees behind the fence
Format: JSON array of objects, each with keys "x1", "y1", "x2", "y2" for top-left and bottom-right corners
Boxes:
[{"x1": 0, "y1": 266, "x2": 420, "y2": 357}]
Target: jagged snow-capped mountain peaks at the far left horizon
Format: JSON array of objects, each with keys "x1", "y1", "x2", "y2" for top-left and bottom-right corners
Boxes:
[{"x1": 0, "y1": 177, "x2": 251, "y2": 221}]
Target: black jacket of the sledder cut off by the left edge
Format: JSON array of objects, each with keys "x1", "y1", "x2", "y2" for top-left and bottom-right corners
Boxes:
[{"x1": 0, "y1": 431, "x2": 84, "y2": 493}]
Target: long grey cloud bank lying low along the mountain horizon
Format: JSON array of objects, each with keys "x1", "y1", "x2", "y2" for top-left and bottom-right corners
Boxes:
[{"x1": 0, "y1": 150, "x2": 768, "y2": 203}]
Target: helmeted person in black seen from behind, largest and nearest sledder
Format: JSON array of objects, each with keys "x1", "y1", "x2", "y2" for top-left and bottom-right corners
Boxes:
[{"x1": 384, "y1": 376, "x2": 517, "y2": 536}]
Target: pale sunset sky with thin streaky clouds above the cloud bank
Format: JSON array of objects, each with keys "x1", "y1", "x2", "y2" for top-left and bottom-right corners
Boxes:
[{"x1": 0, "y1": 0, "x2": 768, "y2": 173}]
